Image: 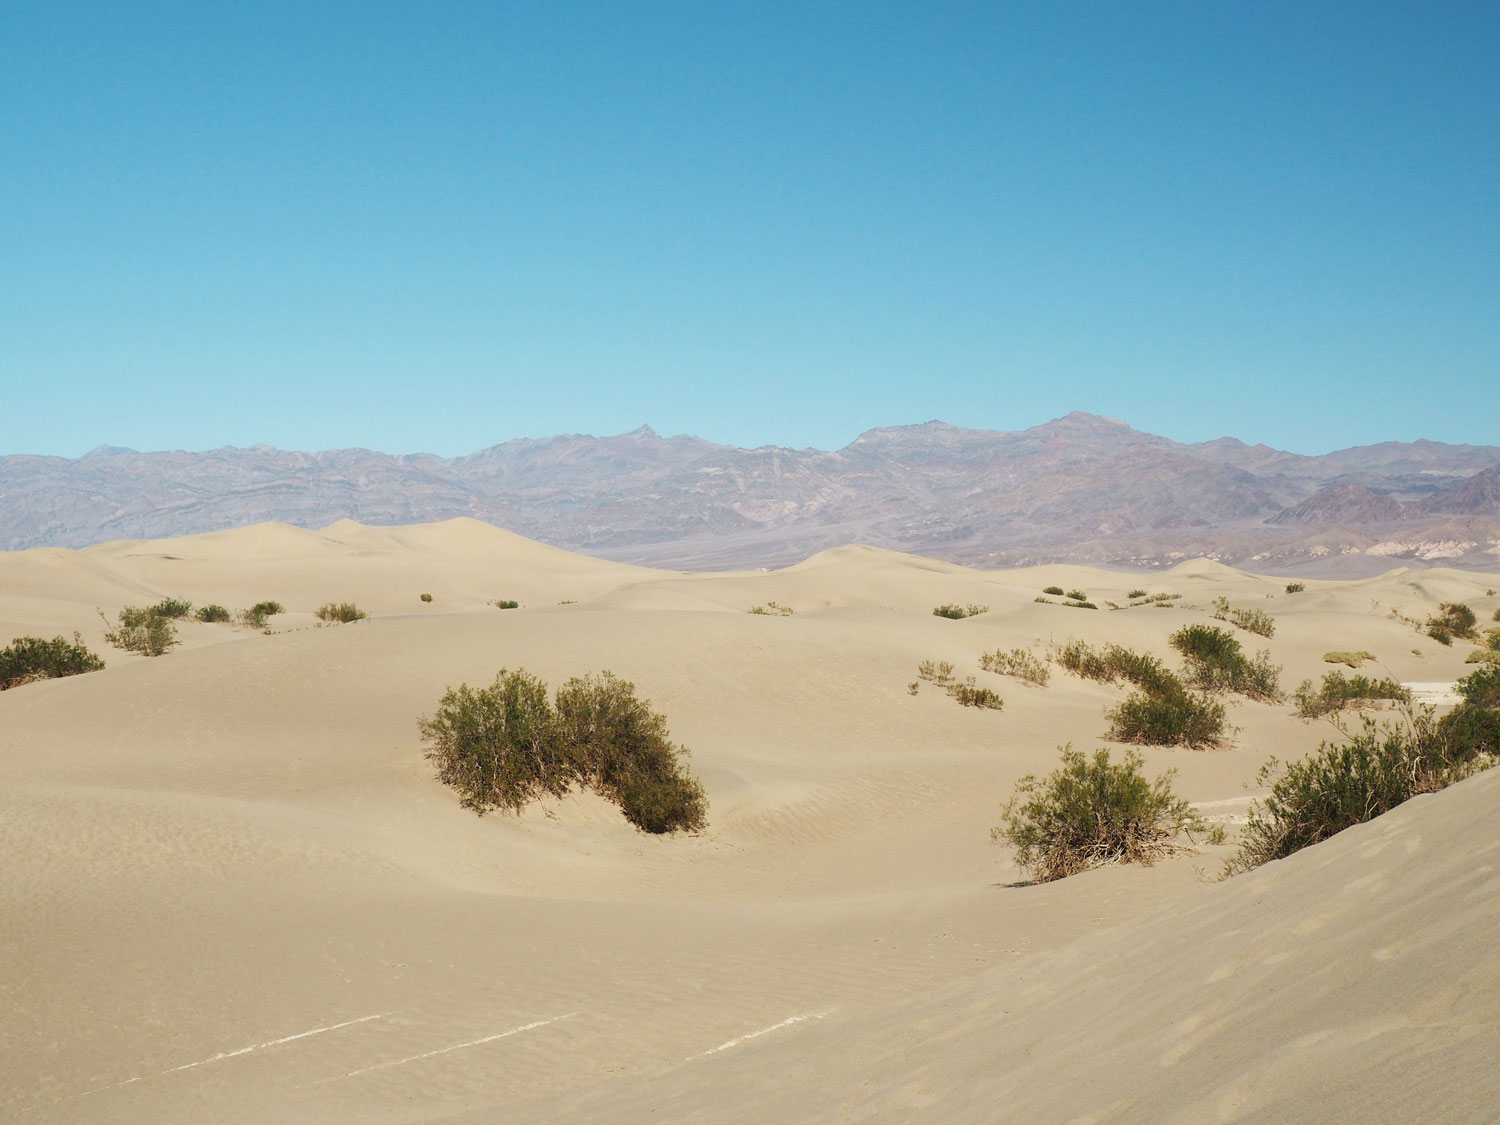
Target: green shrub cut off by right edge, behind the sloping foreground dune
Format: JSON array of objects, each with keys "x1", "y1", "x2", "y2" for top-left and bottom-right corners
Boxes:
[{"x1": 1226, "y1": 708, "x2": 1500, "y2": 873}]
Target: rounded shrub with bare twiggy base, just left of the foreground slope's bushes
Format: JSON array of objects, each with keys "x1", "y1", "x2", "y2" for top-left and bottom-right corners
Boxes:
[{"x1": 990, "y1": 744, "x2": 1203, "y2": 884}]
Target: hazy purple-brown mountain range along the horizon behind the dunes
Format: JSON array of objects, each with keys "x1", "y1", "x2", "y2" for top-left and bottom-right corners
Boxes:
[{"x1": 0, "y1": 413, "x2": 1500, "y2": 575}]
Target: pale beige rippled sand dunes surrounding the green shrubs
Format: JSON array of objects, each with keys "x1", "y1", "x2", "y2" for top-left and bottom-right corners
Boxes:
[{"x1": 0, "y1": 519, "x2": 1500, "y2": 1122}]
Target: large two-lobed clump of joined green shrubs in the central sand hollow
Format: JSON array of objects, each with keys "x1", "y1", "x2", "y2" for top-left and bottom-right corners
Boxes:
[{"x1": 419, "y1": 669, "x2": 708, "y2": 834}]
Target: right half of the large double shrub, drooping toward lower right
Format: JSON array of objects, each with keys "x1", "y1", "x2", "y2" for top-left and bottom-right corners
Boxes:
[{"x1": 557, "y1": 672, "x2": 708, "y2": 833}]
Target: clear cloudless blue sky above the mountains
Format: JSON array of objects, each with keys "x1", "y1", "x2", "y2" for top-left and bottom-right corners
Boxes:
[{"x1": 0, "y1": 0, "x2": 1500, "y2": 456}]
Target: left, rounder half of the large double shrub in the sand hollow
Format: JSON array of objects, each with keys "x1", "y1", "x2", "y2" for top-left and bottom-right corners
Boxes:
[{"x1": 417, "y1": 669, "x2": 575, "y2": 815}]
